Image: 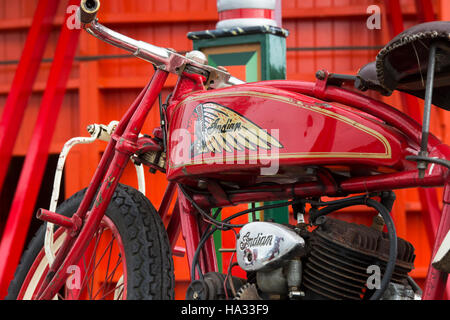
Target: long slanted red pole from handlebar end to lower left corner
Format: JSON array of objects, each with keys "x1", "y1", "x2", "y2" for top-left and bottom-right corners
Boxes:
[{"x1": 0, "y1": 0, "x2": 80, "y2": 298}]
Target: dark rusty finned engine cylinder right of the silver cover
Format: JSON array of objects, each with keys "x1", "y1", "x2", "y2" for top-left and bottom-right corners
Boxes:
[{"x1": 303, "y1": 217, "x2": 415, "y2": 300}]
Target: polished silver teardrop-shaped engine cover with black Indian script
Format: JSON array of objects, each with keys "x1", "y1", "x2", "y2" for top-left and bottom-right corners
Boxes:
[{"x1": 236, "y1": 222, "x2": 305, "y2": 271}]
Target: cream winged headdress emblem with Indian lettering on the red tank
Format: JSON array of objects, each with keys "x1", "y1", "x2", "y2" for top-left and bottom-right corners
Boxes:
[{"x1": 189, "y1": 102, "x2": 283, "y2": 156}]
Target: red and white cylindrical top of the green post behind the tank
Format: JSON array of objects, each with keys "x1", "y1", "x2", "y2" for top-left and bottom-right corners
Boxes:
[{"x1": 216, "y1": 0, "x2": 277, "y2": 29}]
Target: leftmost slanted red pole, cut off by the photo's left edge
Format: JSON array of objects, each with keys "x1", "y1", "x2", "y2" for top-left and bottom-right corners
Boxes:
[{"x1": 0, "y1": 0, "x2": 59, "y2": 196}]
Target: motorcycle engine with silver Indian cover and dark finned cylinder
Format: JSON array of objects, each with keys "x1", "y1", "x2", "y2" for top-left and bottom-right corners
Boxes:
[{"x1": 236, "y1": 217, "x2": 421, "y2": 300}]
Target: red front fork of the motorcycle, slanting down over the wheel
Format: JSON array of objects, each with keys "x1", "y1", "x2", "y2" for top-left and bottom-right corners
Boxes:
[{"x1": 35, "y1": 69, "x2": 168, "y2": 300}]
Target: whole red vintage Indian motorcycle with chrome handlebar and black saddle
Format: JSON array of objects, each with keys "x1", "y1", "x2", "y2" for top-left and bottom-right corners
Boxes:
[{"x1": 7, "y1": 0, "x2": 450, "y2": 300}]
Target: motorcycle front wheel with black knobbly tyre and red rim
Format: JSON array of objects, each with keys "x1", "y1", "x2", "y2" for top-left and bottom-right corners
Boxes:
[{"x1": 6, "y1": 184, "x2": 174, "y2": 300}]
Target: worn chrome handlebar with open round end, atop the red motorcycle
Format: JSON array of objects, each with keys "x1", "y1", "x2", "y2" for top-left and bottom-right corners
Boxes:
[{"x1": 79, "y1": 0, "x2": 245, "y2": 89}]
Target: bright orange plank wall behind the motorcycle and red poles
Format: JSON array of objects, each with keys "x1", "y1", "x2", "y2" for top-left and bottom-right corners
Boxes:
[{"x1": 0, "y1": 0, "x2": 450, "y2": 298}]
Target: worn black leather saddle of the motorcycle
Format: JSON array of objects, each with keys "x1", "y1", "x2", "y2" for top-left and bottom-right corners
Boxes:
[{"x1": 355, "y1": 21, "x2": 450, "y2": 110}]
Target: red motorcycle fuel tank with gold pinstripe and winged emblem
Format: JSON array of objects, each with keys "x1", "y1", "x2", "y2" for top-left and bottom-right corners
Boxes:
[{"x1": 167, "y1": 84, "x2": 415, "y2": 184}]
